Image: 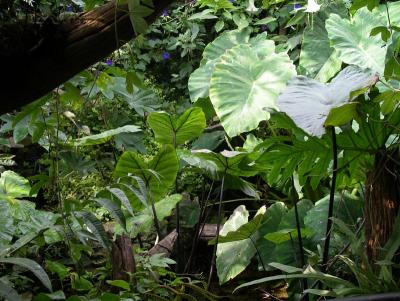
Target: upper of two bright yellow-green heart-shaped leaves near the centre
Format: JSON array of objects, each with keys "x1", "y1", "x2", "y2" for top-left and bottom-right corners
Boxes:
[{"x1": 147, "y1": 107, "x2": 206, "y2": 147}]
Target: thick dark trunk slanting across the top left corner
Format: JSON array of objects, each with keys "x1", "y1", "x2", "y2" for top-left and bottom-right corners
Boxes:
[{"x1": 0, "y1": 0, "x2": 172, "y2": 113}]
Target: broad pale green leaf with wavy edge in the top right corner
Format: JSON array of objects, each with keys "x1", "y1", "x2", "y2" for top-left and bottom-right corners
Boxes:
[{"x1": 326, "y1": 8, "x2": 387, "y2": 75}]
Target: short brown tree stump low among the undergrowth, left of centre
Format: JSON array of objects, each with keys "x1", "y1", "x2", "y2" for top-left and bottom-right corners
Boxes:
[{"x1": 111, "y1": 235, "x2": 136, "y2": 282}]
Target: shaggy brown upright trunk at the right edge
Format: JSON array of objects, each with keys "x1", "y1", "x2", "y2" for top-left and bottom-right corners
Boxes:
[{"x1": 364, "y1": 149, "x2": 400, "y2": 263}]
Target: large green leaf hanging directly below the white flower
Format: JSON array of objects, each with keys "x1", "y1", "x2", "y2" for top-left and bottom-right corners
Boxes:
[{"x1": 299, "y1": 4, "x2": 346, "y2": 82}]
